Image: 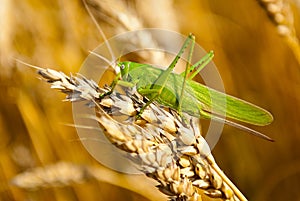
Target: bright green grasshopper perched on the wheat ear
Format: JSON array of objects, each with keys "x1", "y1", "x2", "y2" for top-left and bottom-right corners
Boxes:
[{"x1": 106, "y1": 34, "x2": 273, "y2": 141}]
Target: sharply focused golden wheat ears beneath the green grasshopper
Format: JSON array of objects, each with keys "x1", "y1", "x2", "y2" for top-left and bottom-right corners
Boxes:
[{"x1": 19, "y1": 68, "x2": 247, "y2": 200}]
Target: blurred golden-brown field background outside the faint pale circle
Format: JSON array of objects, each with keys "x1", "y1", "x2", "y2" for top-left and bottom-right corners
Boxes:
[{"x1": 0, "y1": 0, "x2": 300, "y2": 201}]
